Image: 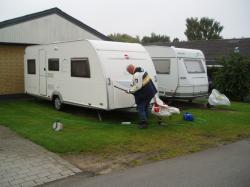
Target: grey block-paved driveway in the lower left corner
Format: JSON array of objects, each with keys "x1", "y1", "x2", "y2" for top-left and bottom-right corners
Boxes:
[{"x1": 0, "y1": 125, "x2": 81, "y2": 187}]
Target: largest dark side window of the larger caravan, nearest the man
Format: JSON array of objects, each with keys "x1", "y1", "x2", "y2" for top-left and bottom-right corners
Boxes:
[{"x1": 71, "y1": 58, "x2": 90, "y2": 78}]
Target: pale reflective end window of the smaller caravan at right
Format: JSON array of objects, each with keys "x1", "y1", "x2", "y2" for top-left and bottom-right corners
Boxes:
[{"x1": 184, "y1": 59, "x2": 205, "y2": 73}]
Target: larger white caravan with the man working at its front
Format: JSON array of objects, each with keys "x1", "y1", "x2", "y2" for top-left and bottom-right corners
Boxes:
[{"x1": 24, "y1": 40, "x2": 156, "y2": 110}]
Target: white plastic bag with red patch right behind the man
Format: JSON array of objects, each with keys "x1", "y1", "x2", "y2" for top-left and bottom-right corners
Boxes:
[{"x1": 151, "y1": 97, "x2": 180, "y2": 116}]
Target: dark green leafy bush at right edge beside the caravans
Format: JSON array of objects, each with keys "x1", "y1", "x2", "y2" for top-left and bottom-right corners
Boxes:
[{"x1": 214, "y1": 53, "x2": 250, "y2": 101}]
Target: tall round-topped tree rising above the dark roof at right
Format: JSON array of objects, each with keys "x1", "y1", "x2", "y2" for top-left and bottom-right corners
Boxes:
[{"x1": 184, "y1": 17, "x2": 224, "y2": 40}]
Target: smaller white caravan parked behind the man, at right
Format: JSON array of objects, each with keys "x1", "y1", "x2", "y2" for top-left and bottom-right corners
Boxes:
[{"x1": 145, "y1": 46, "x2": 208, "y2": 100}]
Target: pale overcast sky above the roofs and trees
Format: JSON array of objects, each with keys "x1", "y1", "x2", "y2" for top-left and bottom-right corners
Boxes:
[{"x1": 0, "y1": 0, "x2": 250, "y2": 40}]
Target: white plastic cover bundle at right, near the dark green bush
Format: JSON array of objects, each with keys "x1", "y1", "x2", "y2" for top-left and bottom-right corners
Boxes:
[{"x1": 208, "y1": 89, "x2": 231, "y2": 106}]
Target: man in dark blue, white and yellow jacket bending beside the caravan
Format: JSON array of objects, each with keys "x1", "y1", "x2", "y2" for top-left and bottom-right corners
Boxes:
[{"x1": 127, "y1": 64, "x2": 157, "y2": 128}]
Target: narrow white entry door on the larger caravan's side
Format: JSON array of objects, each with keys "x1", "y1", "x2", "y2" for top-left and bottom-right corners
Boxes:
[{"x1": 39, "y1": 49, "x2": 47, "y2": 95}]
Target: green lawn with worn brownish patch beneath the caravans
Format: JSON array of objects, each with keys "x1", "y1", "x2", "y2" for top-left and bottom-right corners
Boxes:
[{"x1": 0, "y1": 100, "x2": 250, "y2": 160}]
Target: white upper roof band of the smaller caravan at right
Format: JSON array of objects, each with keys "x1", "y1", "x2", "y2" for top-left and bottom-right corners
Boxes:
[{"x1": 145, "y1": 46, "x2": 205, "y2": 59}]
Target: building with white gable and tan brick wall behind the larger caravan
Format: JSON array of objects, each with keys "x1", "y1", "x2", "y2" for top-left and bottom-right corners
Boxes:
[{"x1": 0, "y1": 8, "x2": 110, "y2": 96}]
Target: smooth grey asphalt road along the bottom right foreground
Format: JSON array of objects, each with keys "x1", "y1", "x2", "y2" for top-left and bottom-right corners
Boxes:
[{"x1": 45, "y1": 140, "x2": 250, "y2": 187}]
